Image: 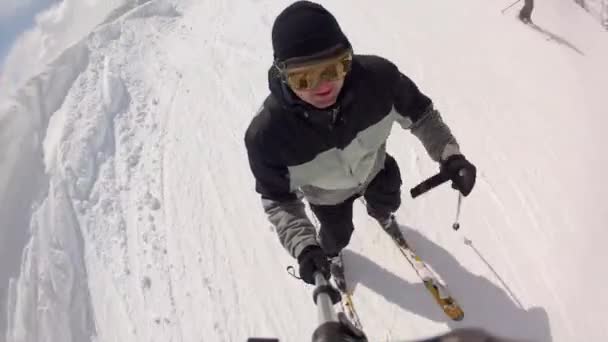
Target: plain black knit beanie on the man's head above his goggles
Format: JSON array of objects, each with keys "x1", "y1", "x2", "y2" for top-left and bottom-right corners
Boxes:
[{"x1": 272, "y1": 1, "x2": 350, "y2": 61}]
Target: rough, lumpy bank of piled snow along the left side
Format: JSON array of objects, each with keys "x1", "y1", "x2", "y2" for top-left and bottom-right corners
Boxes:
[{"x1": 0, "y1": 0, "x2": 179, "y2": 342}]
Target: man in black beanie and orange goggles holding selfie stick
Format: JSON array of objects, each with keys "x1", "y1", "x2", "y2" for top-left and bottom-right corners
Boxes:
[{"x1": 245, "y1": 1, "x2": 476, "y2": 284}]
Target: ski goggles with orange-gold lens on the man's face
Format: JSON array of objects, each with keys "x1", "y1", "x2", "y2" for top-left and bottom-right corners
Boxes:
[{"x1": 279, "y1": 50, "x2": 353, "y2": 91}]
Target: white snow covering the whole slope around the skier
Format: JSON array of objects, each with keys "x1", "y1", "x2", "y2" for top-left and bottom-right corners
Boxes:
[{"x1": 0, "y1": 0, "x2": 608, "y2": 342}]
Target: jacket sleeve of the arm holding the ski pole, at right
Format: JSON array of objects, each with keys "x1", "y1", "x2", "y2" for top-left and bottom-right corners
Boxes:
[{"x1": 393, "y1": 70, "x2": 460, "y2": 161}]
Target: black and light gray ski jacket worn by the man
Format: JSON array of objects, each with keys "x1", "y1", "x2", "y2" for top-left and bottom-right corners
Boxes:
[{"x1": 245, "y1": 55, "x2": 459, "y2": 257}]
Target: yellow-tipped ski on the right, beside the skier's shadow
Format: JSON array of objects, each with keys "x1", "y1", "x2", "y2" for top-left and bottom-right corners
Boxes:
[{"x1": 392, "y1": 235, "x2": 464, "y2": 321}]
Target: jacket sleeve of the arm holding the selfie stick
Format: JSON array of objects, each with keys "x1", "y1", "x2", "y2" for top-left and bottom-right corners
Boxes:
[{"x1": 245, "y1": 121, "x2": 317, "y2": 258}]
